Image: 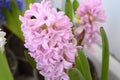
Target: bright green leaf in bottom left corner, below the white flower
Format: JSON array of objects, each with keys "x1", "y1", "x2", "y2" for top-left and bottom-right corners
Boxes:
[{"x1": 0, "y1": 51, "x2": 14, "y2": 80}]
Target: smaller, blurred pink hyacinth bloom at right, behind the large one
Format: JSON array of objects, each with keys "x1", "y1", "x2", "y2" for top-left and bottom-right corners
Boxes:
[{"x1": 76, "y1": 0, "x2": 105, "y2": 47}]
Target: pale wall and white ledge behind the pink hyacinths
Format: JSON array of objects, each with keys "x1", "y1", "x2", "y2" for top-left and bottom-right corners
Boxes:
[{"x1": 49, "y1": 0, "x2": 120, "y2": 80}]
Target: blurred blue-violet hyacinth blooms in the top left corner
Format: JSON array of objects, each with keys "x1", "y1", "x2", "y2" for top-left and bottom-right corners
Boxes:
[{"x1": 0, "y1": 0, "x2": 25, "y2": 23}]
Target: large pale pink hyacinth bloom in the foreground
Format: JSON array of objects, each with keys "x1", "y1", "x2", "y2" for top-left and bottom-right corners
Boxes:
[{"x1": 20, "y1": 0, "x2": 77, "y2": 80}]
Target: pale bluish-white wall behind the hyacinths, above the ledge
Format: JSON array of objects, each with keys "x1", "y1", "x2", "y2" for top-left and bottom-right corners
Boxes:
[{"x1": 50, "y1": 0, "x2": 120, "y2": 61}]
